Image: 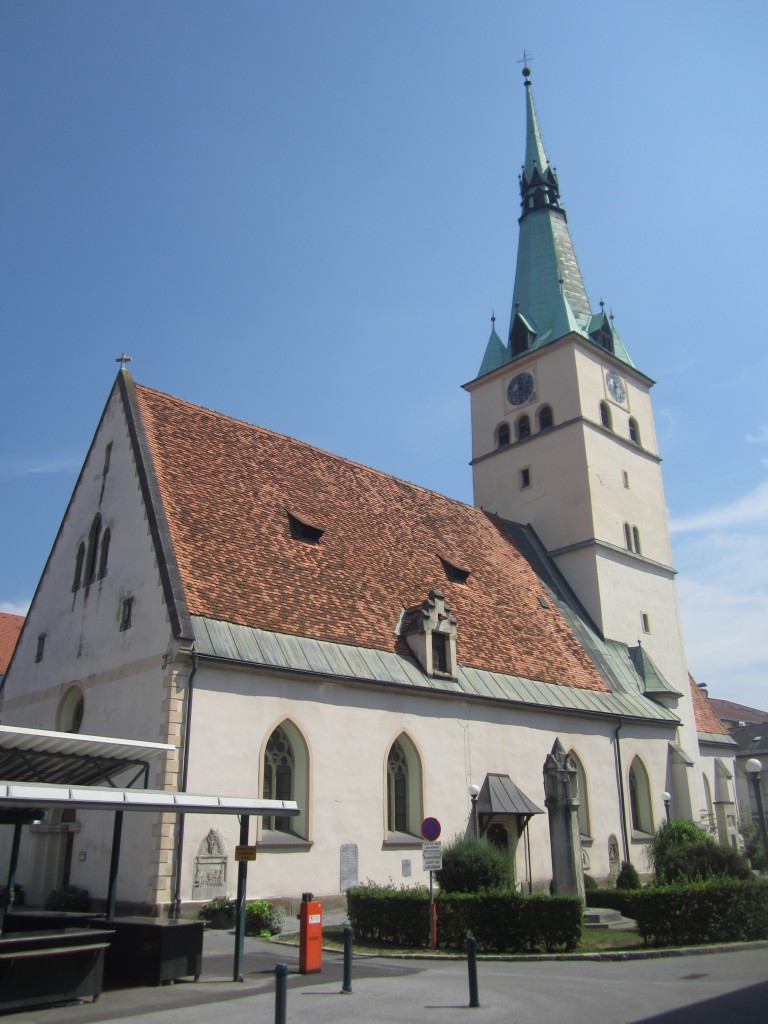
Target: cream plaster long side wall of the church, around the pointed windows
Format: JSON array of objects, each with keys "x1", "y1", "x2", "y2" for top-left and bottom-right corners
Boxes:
[{"x1": 176, "y1": 666, "x2": 674, "y2": 899}]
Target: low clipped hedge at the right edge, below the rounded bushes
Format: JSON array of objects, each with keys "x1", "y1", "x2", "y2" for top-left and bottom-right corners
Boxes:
[{"x1": 630, "y1": 879, "x2": 768, "y2": 946}]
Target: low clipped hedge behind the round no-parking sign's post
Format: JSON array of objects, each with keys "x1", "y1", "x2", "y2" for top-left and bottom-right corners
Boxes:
[{"x1": 347, "y1": 886, "x2": 583, "y2": 952}]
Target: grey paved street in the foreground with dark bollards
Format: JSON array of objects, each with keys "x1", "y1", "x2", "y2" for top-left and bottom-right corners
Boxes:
[{"x1": 9, "y1": 932, "x2": 768, "y2": 1024}]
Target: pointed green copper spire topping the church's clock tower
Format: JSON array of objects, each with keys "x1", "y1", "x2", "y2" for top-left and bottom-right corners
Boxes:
[{"x1": 480, "y1": 66, "x2": 632, "y2": 376}]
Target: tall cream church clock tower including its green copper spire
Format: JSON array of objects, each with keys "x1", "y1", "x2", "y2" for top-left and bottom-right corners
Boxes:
[{"x1": 465, "y1": 67, "x2": 688, "y2": 692}]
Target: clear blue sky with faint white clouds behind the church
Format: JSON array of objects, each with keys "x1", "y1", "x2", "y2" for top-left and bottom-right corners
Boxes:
[{"x1": 0, "y1": 0, "x2": 768, "y2": 708}]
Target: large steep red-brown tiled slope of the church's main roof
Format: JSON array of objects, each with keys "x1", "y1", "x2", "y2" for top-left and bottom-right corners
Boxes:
[{"x1": 136, "y1": 385, "x2": 608, "y2": 690}]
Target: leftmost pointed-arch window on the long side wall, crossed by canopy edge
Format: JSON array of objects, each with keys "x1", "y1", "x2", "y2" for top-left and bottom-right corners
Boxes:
[{"x1": 261, "y1": 721, "x2": 309, "y2": 837}]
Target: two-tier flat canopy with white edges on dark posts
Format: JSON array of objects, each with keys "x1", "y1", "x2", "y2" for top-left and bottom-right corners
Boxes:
[{"x1": 0, "y1": 725, "x2": 299, "y2": 981}]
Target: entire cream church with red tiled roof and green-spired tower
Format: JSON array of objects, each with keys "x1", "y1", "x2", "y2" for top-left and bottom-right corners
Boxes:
[{"x1": 2, "y1": 69, "x2": 736, "y2": 909}]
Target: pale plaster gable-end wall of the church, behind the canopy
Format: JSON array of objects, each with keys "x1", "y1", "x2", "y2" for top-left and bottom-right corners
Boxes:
[{"x1": 2, "y1": 393, "x2": 177, "y2": 902}]
